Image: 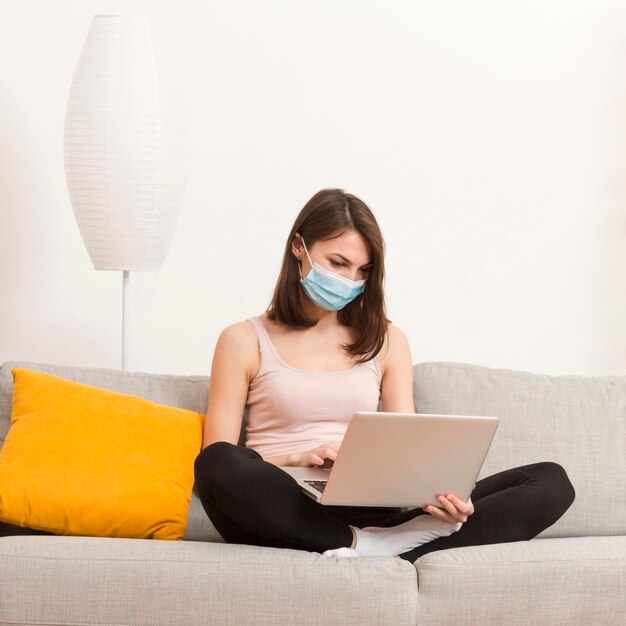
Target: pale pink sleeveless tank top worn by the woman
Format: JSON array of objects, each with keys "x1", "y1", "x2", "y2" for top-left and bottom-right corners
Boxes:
[{"x1": 246, "y1": 316, "x2": 382, "y2": 457}]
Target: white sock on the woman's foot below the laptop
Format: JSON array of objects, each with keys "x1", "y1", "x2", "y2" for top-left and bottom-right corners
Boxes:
[{"x1": 323, "y1": 515, "x2": 463, "y2": 558}]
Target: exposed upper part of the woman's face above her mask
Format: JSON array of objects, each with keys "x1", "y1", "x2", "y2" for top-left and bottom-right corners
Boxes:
[{"x1": 292, "y1": 231, "x2": 372, "y2": 280}]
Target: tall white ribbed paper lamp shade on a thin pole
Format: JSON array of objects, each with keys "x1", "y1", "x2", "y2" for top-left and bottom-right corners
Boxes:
[{"x1": 64, "y1": 15, "x2": 188, "y2": 270}]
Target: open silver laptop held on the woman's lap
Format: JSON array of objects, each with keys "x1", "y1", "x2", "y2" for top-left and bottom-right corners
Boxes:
[{"x1": 280, "y1": 411, "x2": 499, "y2": 510}]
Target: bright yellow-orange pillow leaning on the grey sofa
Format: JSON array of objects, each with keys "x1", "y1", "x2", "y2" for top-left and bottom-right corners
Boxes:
[{"x1": 0, "y1": 367, "x2": 204, "y2": 540}]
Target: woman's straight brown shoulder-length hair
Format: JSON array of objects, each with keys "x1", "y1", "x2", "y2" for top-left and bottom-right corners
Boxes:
[{"x1": 267, "y1": 189, "x2": 391, "y2": 363}]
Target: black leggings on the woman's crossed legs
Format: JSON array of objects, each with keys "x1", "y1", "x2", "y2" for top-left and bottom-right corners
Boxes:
[{"x1": 194, "y1": 441, "x2": 575, "y2": 561}]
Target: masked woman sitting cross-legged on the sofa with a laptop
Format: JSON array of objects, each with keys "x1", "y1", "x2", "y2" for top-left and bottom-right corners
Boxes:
[{"x1": 195, "y1": 189, "x2": 574, "y2": 561}]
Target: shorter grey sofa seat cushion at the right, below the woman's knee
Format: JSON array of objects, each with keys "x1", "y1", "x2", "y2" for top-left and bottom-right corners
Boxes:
[{"x1": 415, "y1": 536, "x2": 626, "y2": 626}]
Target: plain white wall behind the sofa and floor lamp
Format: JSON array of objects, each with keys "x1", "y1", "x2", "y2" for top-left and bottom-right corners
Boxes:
[{"x1": 0, "y1": 0, "x2": 626, "y2": 375}]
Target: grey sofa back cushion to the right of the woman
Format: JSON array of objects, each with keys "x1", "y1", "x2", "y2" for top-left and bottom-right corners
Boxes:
[{"x1": 413, "y1": 362, "x2": 626, "y2": 537}]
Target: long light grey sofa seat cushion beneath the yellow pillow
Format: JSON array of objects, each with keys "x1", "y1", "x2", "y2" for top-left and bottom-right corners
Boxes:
[{"x1": 0, "y1": 536, "x2": 417, "y2": 626}]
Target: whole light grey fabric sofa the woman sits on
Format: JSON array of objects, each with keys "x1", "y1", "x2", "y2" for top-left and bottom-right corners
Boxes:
[{"x1": 0, "y1": 361, "x2": 626, "y2": 626}]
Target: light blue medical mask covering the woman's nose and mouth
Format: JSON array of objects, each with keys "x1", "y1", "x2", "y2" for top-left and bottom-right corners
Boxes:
[{"x1": 298, "y1": 239, "x2": 365, "y2": 311}]
